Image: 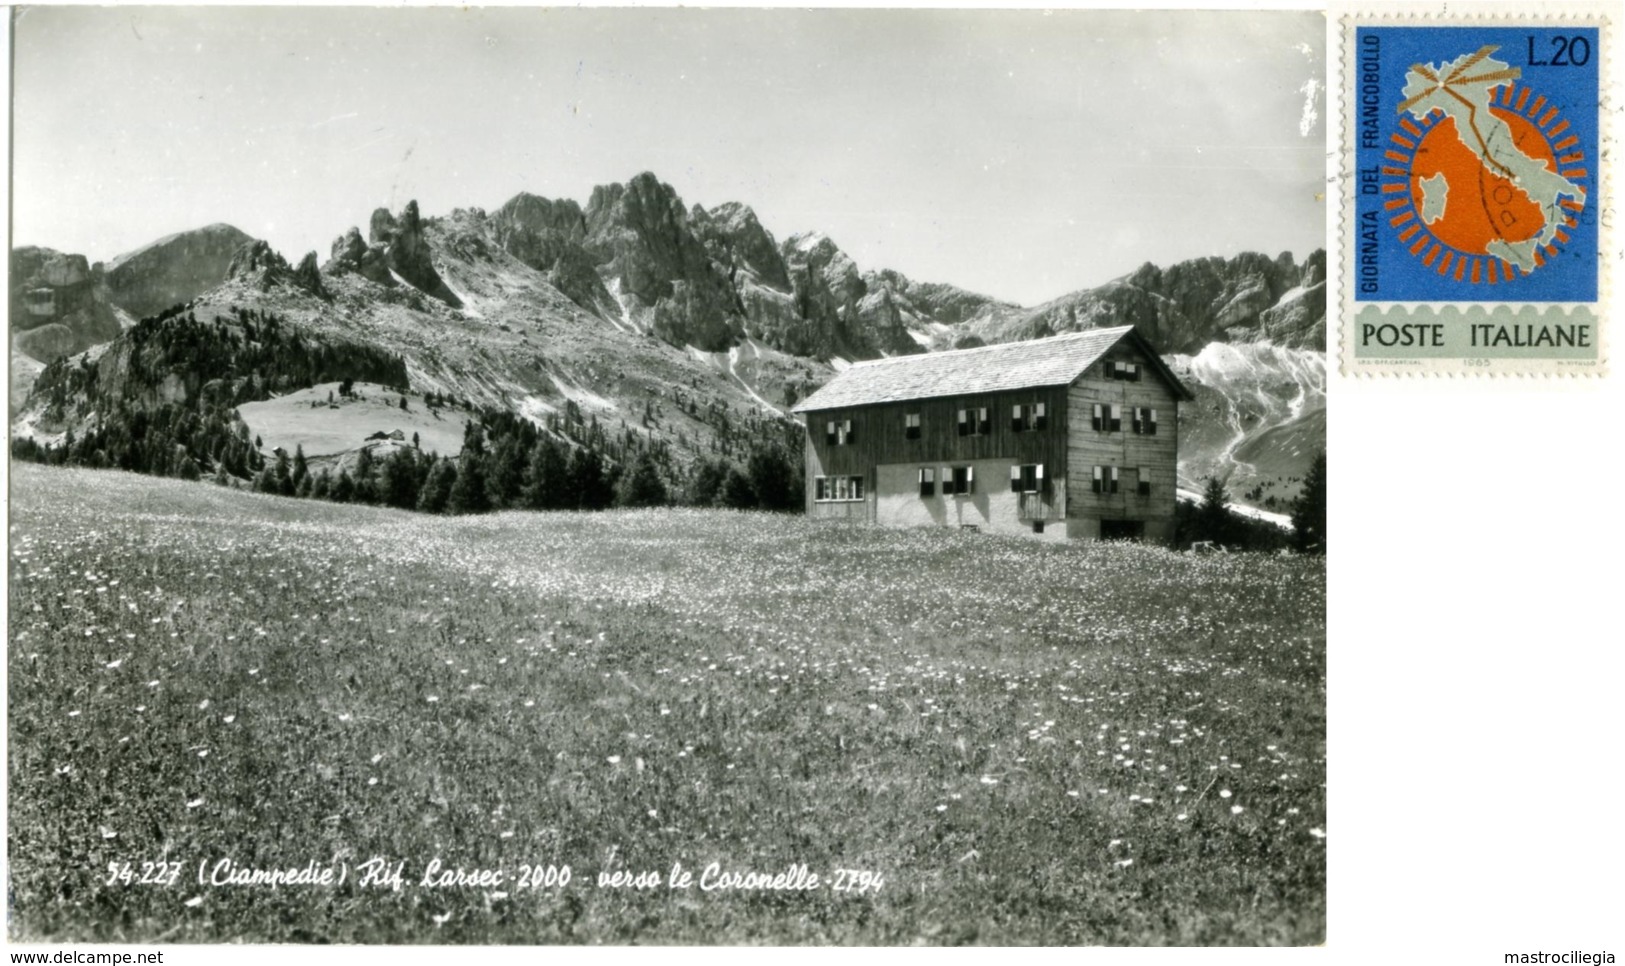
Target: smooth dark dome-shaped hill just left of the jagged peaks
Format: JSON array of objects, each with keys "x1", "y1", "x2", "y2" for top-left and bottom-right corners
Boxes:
[{"x1": 106, "y1": 224, "x2": 254, "y2": 319}]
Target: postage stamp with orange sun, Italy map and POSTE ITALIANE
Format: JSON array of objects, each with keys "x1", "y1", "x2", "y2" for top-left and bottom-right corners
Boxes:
[{"x1": 1339, "y1": 5, "x2": 1612, "y2": 374}]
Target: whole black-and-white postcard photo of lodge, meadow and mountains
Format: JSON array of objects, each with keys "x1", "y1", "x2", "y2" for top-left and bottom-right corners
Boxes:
[{"x1": 5, "y1": 7, "x2": 1332, "y2": 951}]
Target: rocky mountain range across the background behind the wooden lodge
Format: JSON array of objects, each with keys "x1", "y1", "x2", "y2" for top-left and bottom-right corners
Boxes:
[{"x1": 11, "y1": 174, "x2": 1324, "y2": 506}]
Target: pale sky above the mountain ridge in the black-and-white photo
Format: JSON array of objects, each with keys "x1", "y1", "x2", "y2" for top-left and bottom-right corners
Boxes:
[{"x1": 11, "y1": 7, "x2": 1326, "y2": 304}]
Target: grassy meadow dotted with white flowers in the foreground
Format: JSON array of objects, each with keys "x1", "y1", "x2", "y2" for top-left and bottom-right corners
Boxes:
[{"x1": 7, "y1": 463, "x2": 1326, "y2": 945}]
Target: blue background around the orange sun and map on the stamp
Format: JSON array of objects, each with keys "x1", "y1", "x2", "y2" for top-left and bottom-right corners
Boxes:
[{"x1": 1349, "y1": 26, "x2": 1602, "y2": 302}]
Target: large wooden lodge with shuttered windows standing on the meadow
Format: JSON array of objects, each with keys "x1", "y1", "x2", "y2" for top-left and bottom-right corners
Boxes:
[{"x1": 793, "y1": 325, "x2": 1193, "y2": 543}]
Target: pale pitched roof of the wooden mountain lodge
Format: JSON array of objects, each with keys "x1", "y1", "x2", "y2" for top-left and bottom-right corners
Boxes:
[{"x1": 791, "y1": 325, "x2": 1190, "y2": 413}]
